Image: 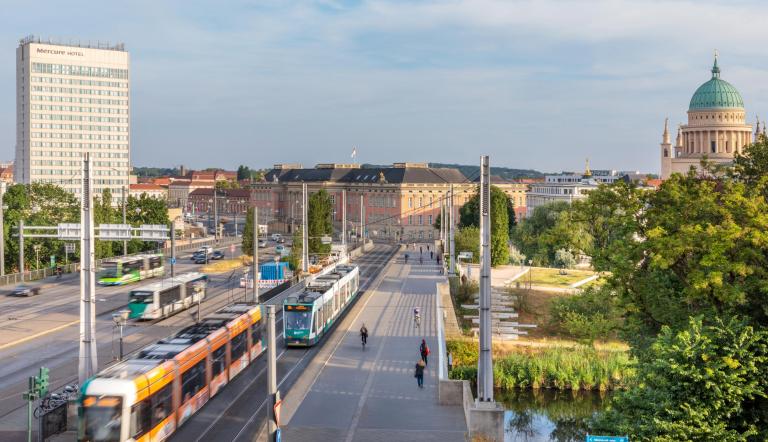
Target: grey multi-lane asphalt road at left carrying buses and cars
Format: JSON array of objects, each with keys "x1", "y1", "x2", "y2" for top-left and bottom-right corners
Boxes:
[{"x1": 0, "y1": 238, "x2": 274, "y2": 440}]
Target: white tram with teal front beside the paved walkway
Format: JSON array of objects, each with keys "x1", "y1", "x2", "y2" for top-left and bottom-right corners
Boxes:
[{"x1": 283, "y1": 265, "x2": 360, "y2": 347}]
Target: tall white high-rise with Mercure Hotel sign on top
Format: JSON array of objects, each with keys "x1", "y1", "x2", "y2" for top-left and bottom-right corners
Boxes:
[{"x1": 14, "y1": 37, "x2": 131, "y2": 203}]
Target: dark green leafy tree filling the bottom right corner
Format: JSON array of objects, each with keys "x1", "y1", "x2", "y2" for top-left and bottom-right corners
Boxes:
[{"x1": 592, "y1": 317, "x2": 768, "y2": 441}]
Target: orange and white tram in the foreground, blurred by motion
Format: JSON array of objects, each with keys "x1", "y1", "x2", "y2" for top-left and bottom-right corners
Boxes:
[{"x1": 78, "y1": 303, "x2": 265, "y2": 442}]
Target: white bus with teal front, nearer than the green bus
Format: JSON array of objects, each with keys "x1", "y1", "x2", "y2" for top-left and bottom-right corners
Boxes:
[{"x1": 128, "y1": 272, "x2": 208, "y2": 319}]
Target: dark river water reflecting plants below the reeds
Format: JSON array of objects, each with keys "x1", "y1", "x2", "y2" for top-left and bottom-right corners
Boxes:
[{"x1": 494, "y1": 389, "x2": 610, "y2": 442}]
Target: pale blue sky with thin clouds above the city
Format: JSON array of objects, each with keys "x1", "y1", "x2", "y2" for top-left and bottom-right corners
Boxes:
[{"x1": 0, "y1": 0, "x2": 768, "y2": 172}]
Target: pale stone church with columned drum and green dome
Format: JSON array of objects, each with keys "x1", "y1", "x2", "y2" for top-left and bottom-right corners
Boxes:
[{"x1": 661, "y1": 56, "x2": 760, "y2": 179}]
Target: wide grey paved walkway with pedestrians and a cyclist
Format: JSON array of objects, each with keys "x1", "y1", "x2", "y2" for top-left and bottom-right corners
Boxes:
[{"x1": 282, "y1": 251, "x2": 467, "y2": 442}]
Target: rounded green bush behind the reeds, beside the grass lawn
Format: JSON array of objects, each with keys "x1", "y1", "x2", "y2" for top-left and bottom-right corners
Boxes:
[{"x1": 551, "y1": 287, "x2": 621, "y2": 342}]
